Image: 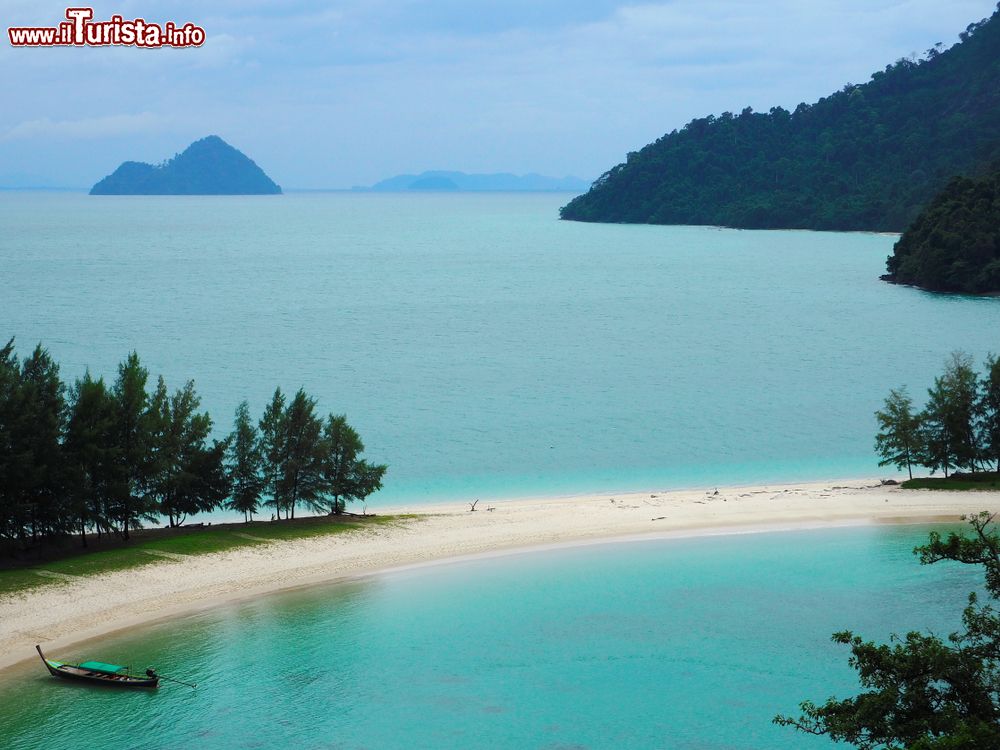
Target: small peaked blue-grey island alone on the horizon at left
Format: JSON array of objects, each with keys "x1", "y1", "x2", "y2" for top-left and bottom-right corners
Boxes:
[{"x1": 90, "y1": 135, "x2": 281, "y2": 195}]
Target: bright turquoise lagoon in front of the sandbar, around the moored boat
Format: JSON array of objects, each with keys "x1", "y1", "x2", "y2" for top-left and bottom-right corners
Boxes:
[{"x1": 0, "y1": 527, "x2": 978, "y2": 750}]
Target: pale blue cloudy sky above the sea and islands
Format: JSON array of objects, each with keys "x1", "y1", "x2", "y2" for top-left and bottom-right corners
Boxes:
[{"x1": 0, "y1": 0, "x2": 996, "y2": 189}]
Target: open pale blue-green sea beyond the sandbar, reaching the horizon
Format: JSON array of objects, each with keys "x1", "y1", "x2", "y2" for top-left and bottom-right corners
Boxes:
[{"x1": 0, "y1": 193, "x2": 1000, "y2": 508}]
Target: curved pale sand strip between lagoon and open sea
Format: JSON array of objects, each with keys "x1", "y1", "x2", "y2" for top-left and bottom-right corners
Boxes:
[{"x1": 0, "y1": 480, "x2": 1000, "y2": 669}]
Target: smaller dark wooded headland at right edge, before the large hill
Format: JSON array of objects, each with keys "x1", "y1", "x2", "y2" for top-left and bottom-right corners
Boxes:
[{"x1": 884, "y1": 164, "x2": 1000, "y2": 293}]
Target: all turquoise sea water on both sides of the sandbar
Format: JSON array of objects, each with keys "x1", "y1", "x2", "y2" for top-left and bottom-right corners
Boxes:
[{"x1": 0, "y1": 193, "x2": 1000, "y2": 750}]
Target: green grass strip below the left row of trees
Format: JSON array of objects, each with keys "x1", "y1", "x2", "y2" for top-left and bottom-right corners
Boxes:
[{"x1": 0, "y1": 516, "x2": 415, "y2": 596}]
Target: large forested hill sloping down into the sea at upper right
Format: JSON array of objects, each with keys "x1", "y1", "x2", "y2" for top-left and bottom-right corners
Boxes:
[{"x1": 560, "y1": 5, "x2": 1000, "y2": 231}]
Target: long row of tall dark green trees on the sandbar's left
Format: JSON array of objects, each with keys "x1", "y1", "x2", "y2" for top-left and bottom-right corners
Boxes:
[{"x1": 0, "y1": 339, "x2": 387, "y2": 547}]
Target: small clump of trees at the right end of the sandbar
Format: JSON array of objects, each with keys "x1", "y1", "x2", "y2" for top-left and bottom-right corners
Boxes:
[{"x1": 875, "y1": 352, "x2": 1000, "y2": 479}]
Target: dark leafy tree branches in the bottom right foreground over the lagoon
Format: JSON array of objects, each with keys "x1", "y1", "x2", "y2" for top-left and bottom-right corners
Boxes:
[{"x1": 775, "y1": 513, "x2": 1000, "y2": 750}]
